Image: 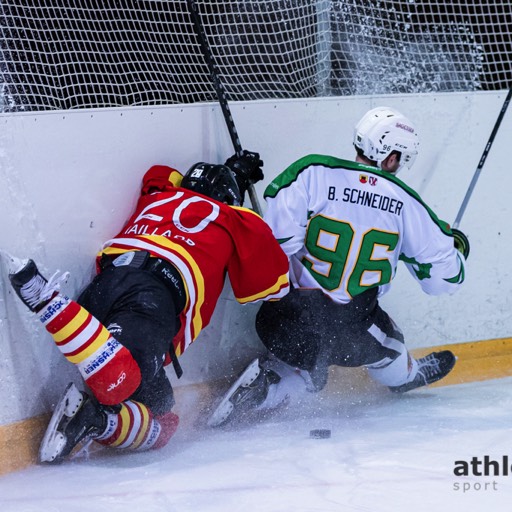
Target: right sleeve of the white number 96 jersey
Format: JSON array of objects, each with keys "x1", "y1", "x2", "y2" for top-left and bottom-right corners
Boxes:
[{"x1": 400, "y1": 203, "x2": 465, "y2": 295}]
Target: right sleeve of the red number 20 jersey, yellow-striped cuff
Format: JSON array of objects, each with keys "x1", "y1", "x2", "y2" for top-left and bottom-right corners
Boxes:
[{"x1": 228, "y1": 207, "x2": 289, "y2": 304}]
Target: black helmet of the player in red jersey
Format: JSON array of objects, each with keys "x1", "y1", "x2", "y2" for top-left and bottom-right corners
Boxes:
[{"x1": 181, "y1": 162, "x2": 242, "y2": 206}]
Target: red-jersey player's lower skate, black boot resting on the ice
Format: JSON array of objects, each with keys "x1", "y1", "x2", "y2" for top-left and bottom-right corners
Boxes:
[{"x1": 39, "y1": 383, "x2": 108, "y2": 464}]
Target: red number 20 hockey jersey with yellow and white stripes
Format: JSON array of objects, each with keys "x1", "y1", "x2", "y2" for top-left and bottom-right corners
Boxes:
[{"x1": 98, "y1": 165, "x2": 289, "y2": 355}]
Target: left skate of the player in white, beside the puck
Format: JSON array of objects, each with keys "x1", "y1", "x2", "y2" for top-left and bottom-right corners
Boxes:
[{"x1": 207, "y1": 359, "x2": 281, "y2": 427}]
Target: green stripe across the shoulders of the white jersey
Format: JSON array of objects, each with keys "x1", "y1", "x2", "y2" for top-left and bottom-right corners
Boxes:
[{"x1": 263, "y1": 154, "x2": 452, "y2": 236}]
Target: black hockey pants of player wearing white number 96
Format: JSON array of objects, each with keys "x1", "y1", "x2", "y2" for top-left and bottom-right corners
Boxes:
[{"x1": 256, "y1": 288, "x2": 404, "y2": 390}]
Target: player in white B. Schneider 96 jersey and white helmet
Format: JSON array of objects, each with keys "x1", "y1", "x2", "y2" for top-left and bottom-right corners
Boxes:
[{"x1": 209, "y1": 107, "x2": 469, "y2": 426}]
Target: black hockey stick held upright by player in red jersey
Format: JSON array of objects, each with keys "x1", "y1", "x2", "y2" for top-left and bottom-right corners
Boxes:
[{"x1": 187, "y1": 0, "x2": 261, "y2": 215}]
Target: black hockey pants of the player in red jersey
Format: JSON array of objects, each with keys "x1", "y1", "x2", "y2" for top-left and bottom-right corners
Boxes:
[{"x1": 77, "y1": 256, "x2": 181, "y2": 415}]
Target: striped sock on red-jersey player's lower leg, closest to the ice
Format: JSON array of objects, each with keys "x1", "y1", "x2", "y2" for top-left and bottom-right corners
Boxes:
[{"x1": 96, "y1": 400, "x2": 179, "y2": 451}]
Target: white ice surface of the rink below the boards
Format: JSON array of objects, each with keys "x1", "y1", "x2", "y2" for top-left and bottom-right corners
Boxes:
[{"x1": 0, "y1": 378, "x2": 512, "y2": 512}]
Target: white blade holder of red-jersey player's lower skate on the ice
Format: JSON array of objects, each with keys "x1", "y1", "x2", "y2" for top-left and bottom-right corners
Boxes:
[{"x1": 38, "y1": 383, "x2": 83, "y2": 463}]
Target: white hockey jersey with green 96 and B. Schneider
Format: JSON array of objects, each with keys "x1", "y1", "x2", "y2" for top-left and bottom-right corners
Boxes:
[{"x1": 264, "y1": 155, "x2": 464, "y2": 303}]
